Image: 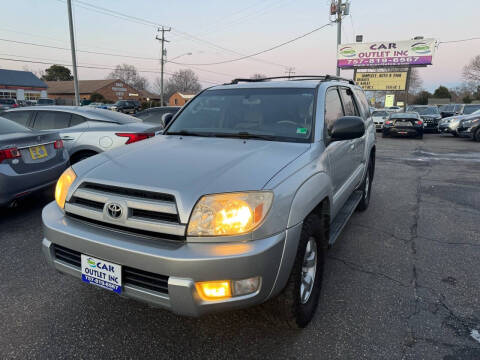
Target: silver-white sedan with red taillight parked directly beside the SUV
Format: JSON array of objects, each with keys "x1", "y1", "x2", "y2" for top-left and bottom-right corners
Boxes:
[{"x1": 1, "y1": 106, "x2": 160, "y2": 164}]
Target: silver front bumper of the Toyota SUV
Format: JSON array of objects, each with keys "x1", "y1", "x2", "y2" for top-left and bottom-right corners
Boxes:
[{"x1": 42, "y1": 202, "x2": 302, "y2": 316}]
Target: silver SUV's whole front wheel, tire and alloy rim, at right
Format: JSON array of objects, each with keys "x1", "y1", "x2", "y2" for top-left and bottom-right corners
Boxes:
[{"x1": 269, "y1": 214, "x2": 325, "y2": 328}]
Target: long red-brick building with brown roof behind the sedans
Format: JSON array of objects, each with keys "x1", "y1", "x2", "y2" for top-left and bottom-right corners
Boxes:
[{"x1": 47, "y1": 79, "x2": 155, "y2": 105}]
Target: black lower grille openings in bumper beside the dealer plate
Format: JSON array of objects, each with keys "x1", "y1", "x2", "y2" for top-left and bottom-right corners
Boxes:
[{"x1": 53, "y1": 244, "x2": 168, "y2": 294}]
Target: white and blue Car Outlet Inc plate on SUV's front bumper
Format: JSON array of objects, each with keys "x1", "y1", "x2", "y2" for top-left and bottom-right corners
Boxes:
[{"x1": 82, "y1": 254, "x2": 122, "y2": 294}]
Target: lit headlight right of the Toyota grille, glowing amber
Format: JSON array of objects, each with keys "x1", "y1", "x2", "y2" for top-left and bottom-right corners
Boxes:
[{"x1": 187, "y1": 191, "x2": 273, "y2": 236}]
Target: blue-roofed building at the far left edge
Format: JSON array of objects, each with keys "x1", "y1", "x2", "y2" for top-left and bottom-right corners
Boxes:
[{"x1": 0, "y1": 69, "x2": 47, "y2": 100}]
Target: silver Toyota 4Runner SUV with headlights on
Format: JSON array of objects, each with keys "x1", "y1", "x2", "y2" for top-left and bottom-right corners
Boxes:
[{"x1": 42, "y1": 75, "x2": 375, "y2": 327}]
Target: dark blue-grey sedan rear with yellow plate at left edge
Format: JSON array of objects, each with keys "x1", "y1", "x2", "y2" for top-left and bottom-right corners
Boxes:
[{"x1": 0, "y1": 117, "x2": 68, "y2": 207}]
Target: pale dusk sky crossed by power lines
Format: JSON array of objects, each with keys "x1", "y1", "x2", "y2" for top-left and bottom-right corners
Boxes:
[{"x1": 0, "y1": 0, "x2": 480, "y2": 90}]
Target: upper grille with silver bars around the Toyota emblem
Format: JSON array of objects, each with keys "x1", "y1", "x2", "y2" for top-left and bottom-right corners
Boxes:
[{"x1": 65, "y1": 182, "x2": 186, "y2": 240}]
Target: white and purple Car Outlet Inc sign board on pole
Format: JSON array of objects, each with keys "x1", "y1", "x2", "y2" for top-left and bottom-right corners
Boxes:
[{"x1": 337, "y1": 39, "x2": 436, "y2": 69}]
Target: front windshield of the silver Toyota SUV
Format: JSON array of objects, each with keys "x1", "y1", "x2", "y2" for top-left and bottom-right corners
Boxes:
[{"x1": 167, "y1": 88, "x2": 315, "y2": 142}]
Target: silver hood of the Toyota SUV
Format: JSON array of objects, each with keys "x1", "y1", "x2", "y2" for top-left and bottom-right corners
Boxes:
[{"x1": 74, "y1": 135, "x2": 310, "y2": 217}]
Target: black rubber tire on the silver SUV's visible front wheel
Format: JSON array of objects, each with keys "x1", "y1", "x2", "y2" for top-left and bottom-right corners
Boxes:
[{"x1": 268, "y1": 214, "x2": 327, "y2": 329}]
